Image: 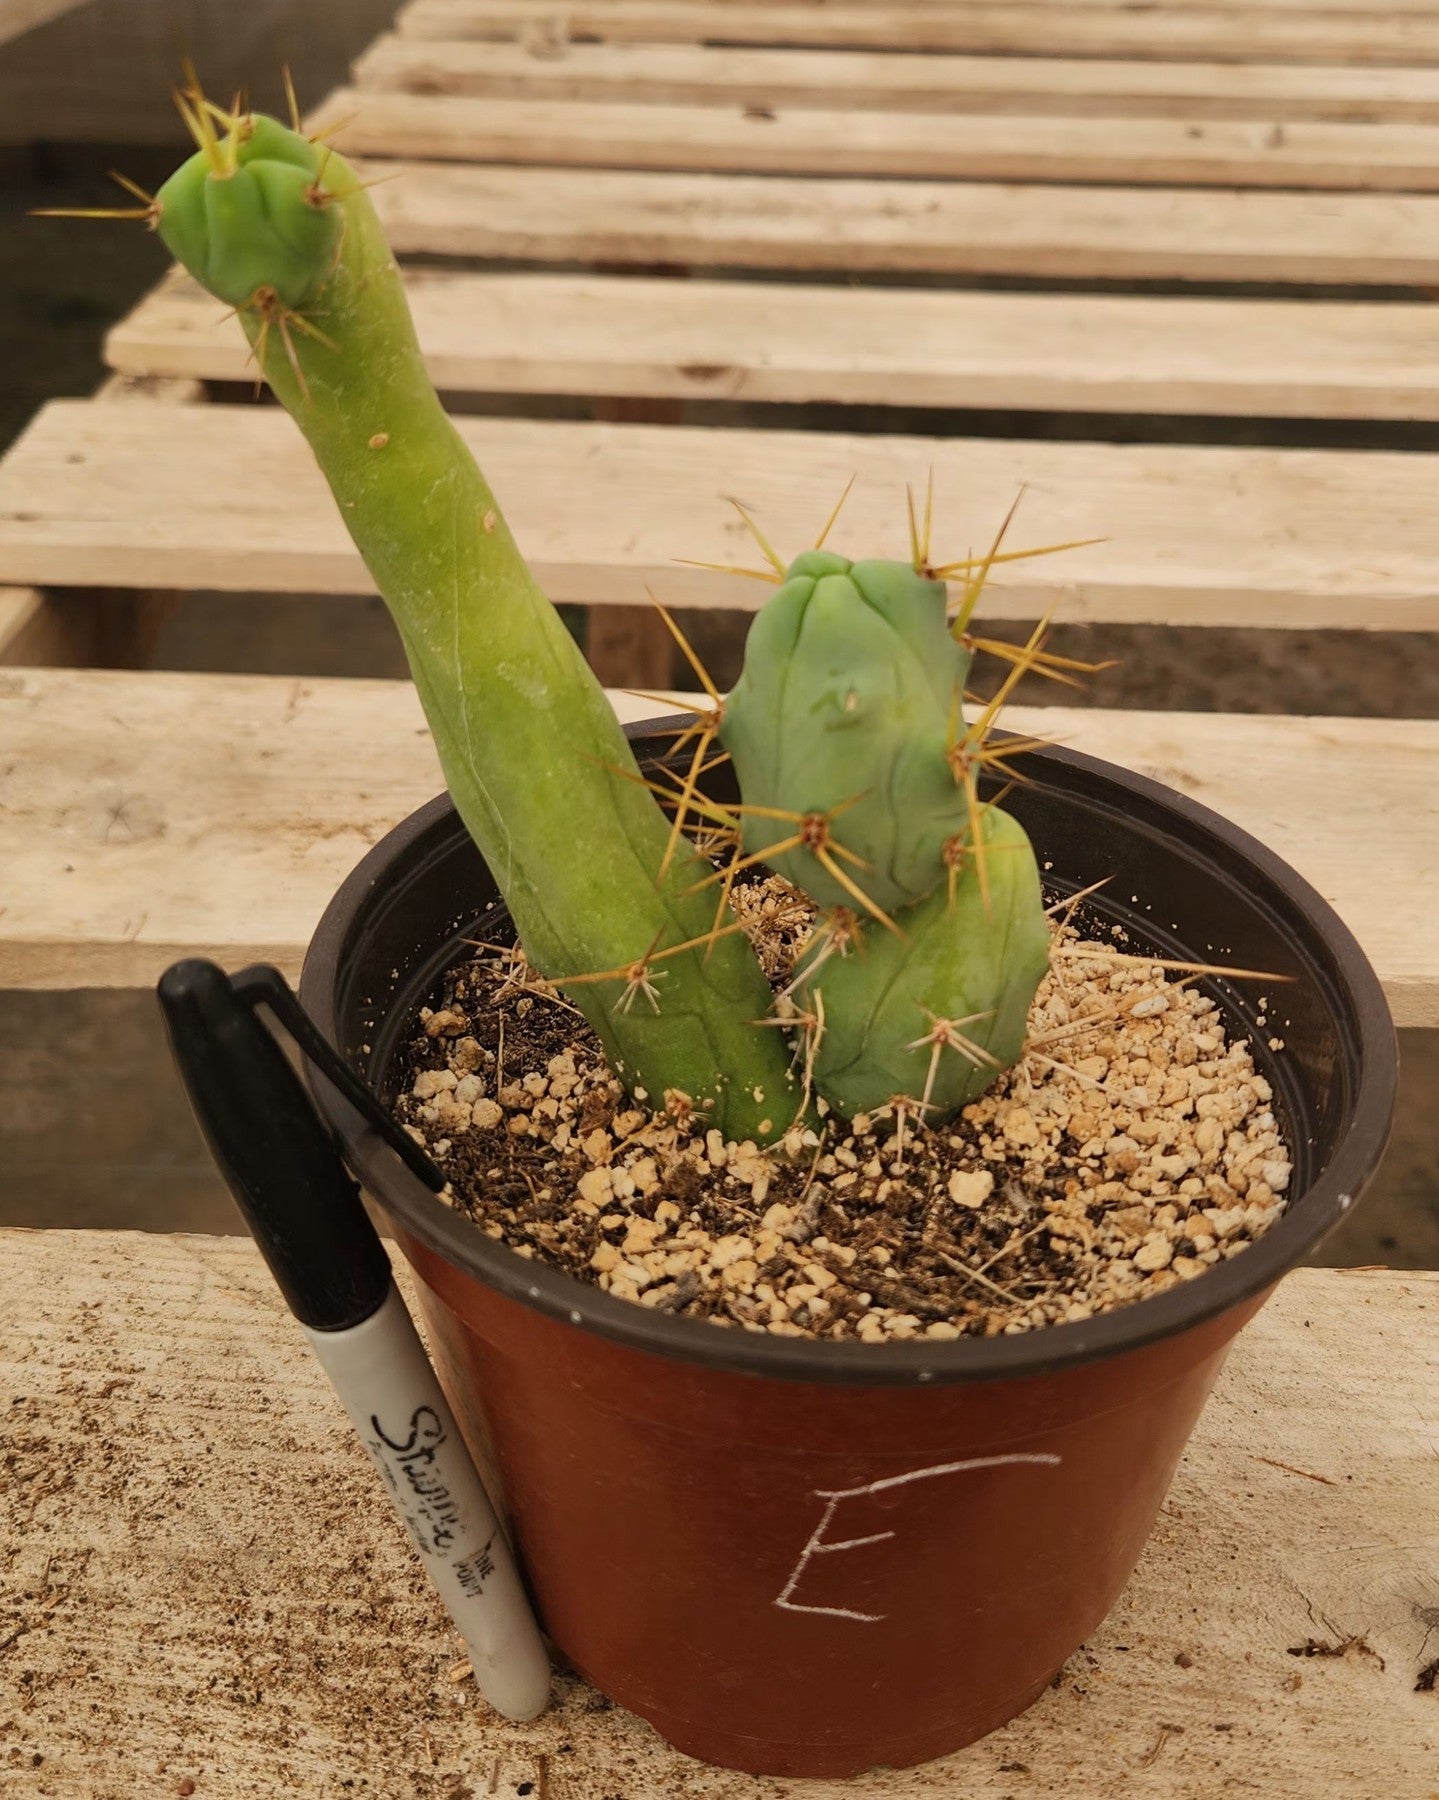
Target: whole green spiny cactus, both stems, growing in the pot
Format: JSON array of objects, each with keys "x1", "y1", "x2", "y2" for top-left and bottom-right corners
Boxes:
[{"x1": 151, "y1": 105, "x2": 1048, "y2": 1141}]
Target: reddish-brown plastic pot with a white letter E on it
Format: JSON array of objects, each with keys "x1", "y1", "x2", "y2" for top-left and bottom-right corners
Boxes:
[{"x1": 301, "y1": 727, "x2": 1396, "y2": 1777}]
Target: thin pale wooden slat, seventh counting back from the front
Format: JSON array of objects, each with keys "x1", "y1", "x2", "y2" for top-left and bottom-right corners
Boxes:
[{"x1": 355, "y1": 34, "x2": 1439, "y2": 122}]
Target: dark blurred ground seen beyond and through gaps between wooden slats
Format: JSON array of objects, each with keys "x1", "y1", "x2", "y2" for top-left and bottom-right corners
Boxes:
[{"x1": 0, "y1": 0, "x2": 1439, "y2": 1267}]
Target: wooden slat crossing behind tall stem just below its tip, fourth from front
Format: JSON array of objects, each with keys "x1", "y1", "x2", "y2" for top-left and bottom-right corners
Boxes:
[{"x1": 104, "y1": 268, "x2": 1439, "y2": 419}]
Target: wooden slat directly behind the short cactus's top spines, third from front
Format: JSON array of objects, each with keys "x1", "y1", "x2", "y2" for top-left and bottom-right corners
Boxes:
[{"x1": 0, "y1": 401, "x2": 1439, "y2": 630}]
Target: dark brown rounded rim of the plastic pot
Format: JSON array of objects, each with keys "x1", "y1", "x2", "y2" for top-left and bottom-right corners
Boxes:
[{"x1": 301, "y1": 716, "x2": 1398, "y2": 1388}]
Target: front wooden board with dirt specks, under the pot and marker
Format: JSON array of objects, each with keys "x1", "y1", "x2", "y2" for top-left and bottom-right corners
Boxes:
[{"x1": 0, "y1": 1231, "x2": 1439, "y2": 1800}]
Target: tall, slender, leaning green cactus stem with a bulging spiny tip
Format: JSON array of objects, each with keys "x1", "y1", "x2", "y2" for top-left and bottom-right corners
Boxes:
[{"x1": 155, "y1": 112, "x2": 796, "y2": 1139}]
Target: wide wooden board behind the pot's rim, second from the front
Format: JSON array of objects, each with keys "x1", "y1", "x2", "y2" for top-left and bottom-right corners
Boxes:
[{"x1": 0, "y1": 670, "x2": 1439, "y2": 1024}]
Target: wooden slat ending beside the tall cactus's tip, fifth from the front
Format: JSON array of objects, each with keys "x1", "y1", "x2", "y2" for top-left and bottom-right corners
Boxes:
[{"x1": 320, "y1": 162, "x2": 1439, "y2": 286}]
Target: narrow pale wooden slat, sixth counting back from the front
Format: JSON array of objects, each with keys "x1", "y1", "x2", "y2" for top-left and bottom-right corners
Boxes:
[{"x1": 312, "y1": 88, "x2": 1439, "y2": 193}]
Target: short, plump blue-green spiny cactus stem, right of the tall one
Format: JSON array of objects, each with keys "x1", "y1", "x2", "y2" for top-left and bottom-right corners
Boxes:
[{"x1": 724, "y1": 551, "x2": 1050, "y2": 1125}]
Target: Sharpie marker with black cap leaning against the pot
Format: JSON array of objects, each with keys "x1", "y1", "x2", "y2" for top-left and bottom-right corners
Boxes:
[{"x1": 158, "y1": 958, "x2": 549, "y2": 1719}]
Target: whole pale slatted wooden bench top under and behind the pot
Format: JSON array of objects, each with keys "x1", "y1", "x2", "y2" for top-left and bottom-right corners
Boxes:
[{"x1": 0, "y1": 10, "x2": 1439, "y2": 1800}]
